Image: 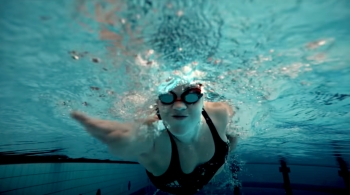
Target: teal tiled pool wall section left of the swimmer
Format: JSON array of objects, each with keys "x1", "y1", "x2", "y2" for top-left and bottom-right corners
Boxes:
[{"x1": 0, "y1": 163, "x2": 150, "y2": 195}]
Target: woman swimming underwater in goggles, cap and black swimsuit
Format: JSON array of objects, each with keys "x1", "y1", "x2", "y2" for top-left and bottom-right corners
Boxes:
[{"x1": 72, "y1": 80, "x2": 237, "y2": 194}]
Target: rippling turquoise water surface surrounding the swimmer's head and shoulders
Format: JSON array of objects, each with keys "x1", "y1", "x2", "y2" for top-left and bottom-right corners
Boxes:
[{"x1": 0, "y1": 0, "x2": 350, "y2": 186}]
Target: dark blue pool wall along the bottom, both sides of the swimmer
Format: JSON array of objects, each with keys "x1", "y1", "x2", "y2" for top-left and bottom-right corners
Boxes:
[{"x1": 0, "y1": 156, "x2": 350, "y2": 195}]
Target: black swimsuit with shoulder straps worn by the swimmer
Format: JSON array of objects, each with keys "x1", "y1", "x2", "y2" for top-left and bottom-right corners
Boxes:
[{"x1": 146, "y1": 109, "x2": 229, "y2": 194}]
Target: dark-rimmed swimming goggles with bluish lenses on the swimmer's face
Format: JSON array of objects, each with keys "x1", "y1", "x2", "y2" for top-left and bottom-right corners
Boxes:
[{"x1": 158, "y1": 88, "x2": 203, "y2": 105}]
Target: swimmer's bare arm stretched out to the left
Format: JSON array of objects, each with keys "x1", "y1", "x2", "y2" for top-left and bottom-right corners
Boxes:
[{"x1": 71, "y1": 112, "x2": 158, "y2": 159}]
